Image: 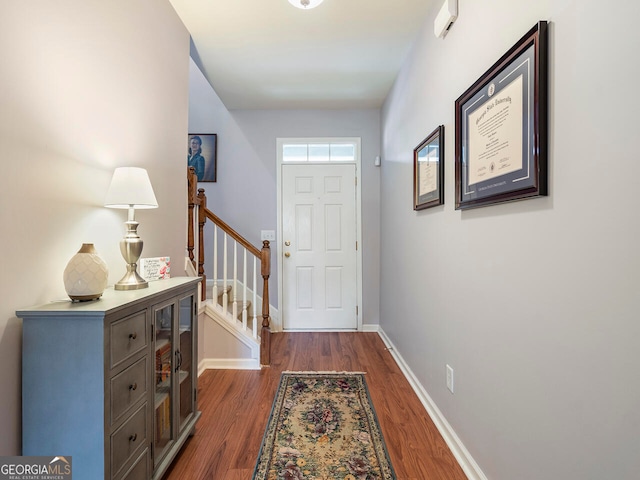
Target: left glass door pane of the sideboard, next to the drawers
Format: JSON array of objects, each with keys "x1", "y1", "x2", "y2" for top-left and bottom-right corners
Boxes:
[{"x1": 154, "y1": 304, "x2": 175, "y2": 464}]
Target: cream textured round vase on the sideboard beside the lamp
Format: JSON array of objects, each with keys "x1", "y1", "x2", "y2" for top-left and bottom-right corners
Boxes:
[{"x1": 63, "y1": 243, "x2": 109, "y2": 302}]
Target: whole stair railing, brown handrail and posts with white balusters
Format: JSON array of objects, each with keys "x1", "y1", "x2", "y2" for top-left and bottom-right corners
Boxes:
[{"x1": 187, "y1": 167, "x2": 271, "y2": 365}]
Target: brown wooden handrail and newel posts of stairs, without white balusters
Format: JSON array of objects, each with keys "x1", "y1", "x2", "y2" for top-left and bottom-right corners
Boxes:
[{"x1": 187, "y1": 167, "x2": 271, "y2": 366}]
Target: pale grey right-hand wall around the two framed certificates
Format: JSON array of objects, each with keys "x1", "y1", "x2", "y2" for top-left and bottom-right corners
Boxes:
[{"x1": 381, "y1": 0, "x2": 640, "y2": 480}]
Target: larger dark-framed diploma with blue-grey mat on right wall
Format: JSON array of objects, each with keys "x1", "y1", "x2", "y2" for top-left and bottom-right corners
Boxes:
[{"x1": 455, "y1": 21, "x2": 548, "y2": 210}]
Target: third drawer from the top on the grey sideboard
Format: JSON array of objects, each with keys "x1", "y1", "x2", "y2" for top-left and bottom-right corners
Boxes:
[{"x1": 111, "y1": 403, "x2": 148, "y2": 477}]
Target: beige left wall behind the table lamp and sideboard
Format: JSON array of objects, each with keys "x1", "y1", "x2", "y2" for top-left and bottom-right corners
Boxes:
[{"x1": 0, "y1": 0, "x2": 189, "y2": 455}]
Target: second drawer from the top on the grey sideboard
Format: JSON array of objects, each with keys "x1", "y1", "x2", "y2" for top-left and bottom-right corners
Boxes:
[{"x1": 110, "y1": 357, "x2": 149, "y2": 425}]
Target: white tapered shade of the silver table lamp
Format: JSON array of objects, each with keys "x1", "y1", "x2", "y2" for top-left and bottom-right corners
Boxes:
[{"x1": 104, "y1": 167, "x2": 158, "y2": 209}]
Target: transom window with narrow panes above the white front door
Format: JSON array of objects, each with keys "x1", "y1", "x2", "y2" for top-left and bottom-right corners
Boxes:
[{"x1": 282, "y1": 141, "x2": 357, "y2": 163}]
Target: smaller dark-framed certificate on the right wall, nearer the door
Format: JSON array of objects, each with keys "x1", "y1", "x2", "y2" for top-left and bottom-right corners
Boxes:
[{"x1": 413, "y1": 125, "x2": 444, "y2": 210}]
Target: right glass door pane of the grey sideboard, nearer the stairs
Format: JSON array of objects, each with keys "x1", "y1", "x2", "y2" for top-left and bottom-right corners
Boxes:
[{"x1": 178, "y1": 295, "x2": 195, "y2": 431}]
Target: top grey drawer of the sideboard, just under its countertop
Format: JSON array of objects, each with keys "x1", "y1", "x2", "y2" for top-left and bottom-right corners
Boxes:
[{"x1": 109, "y1": 310, "x2": 149, "y2": 368}]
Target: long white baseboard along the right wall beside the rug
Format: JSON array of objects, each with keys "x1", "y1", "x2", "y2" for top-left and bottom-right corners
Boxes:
[{"x1": 377, "y1": 326, "x2": 487, "y2": 480}]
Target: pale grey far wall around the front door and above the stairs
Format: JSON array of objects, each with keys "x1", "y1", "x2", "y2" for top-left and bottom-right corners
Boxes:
[{"x1": 189, "y1": 61, "x2": 380, "y2": 324}]
